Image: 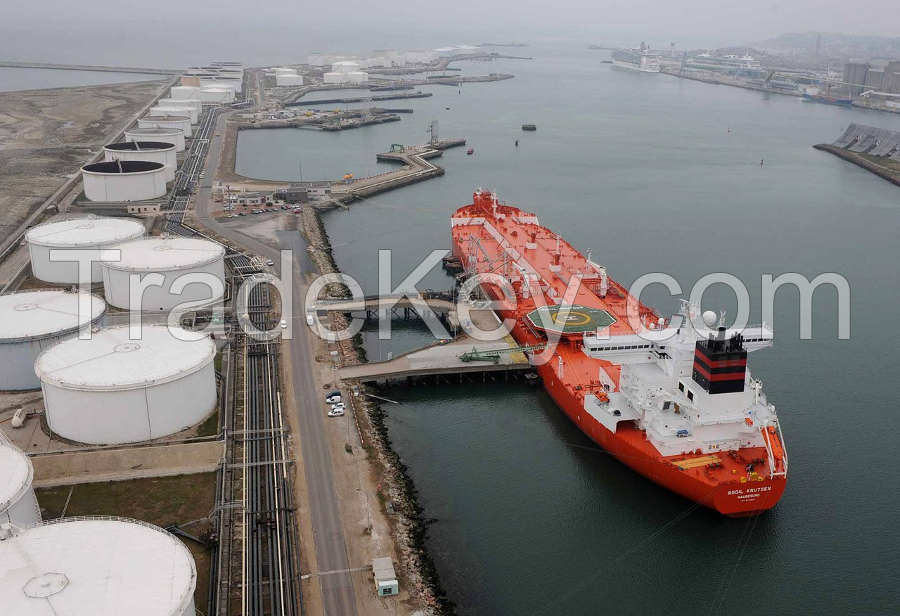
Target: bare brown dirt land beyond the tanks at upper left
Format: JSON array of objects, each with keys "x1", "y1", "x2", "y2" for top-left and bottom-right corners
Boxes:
[{"x1": 0, "y1": 80, "x2": 168, "y2": 245}]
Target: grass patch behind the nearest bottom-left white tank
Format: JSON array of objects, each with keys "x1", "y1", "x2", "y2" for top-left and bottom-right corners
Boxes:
[{"x1": 35, "y1": 473, "x2": 216, "y2": 611}]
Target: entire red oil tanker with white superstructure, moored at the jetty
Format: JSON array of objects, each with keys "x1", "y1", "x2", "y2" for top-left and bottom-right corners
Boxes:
[{"x1": 452, "y1": 190, "x2": 788, "y2": 517}]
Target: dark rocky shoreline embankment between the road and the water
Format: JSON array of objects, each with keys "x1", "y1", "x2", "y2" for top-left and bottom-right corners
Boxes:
[{"x1": 301, "y1": 207, "x2": 456, "y2": 616}]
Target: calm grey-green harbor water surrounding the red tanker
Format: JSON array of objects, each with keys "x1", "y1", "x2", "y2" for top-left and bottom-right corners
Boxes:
[{"x1": 239, "y1": 47, "x2": 900, "y2": 616}]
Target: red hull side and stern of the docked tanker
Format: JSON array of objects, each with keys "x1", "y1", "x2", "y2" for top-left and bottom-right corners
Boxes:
[{"x1": 453, "y1": 235, "x2": 787, "y2": 518}]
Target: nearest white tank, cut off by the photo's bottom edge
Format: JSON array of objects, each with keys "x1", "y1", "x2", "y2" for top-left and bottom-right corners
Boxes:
[{"x1": 0, "y1": 517, "x2": 197, "y2": 616}]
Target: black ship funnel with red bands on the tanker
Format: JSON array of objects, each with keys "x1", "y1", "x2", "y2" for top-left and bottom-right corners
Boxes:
[{"x1": 693, "y1": 326, "x2": 747, "y2": 394}]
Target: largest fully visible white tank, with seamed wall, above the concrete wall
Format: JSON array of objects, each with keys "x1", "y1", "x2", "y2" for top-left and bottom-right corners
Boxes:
[{"x1": 34, "y1": 325, "x2": 216, "y2": 445}]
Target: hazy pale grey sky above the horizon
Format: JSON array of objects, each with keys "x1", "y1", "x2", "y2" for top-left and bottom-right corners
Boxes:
[{"x1": 0, "y1": 0, "x2": 900, "y2": 66}]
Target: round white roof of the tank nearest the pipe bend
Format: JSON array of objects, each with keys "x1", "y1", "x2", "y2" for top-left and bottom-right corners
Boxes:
[{"x1": 100, "y1": 237, "x2": 225, "y2": 271}]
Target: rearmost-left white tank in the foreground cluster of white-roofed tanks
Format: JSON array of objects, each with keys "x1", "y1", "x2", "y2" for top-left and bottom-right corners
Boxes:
[{"x1": 25, "y1": 216, "x2": 146, "y2": 284}]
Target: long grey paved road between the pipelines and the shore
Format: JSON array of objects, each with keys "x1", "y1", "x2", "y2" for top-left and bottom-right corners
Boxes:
[{"x1": 196, "y1": 113, "x2": 359, "y2": 616}]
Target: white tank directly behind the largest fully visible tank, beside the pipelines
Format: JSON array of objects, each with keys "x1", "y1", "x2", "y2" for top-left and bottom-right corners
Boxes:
[{"x1": 100, "y1": 237, "x2": 225, "y2": 312}]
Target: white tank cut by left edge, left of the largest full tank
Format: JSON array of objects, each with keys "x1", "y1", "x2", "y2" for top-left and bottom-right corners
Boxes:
[{"x1": 0, "y1": 290, "x2": 106, "y2": 391}]
